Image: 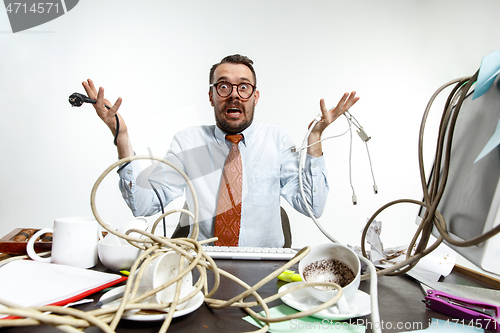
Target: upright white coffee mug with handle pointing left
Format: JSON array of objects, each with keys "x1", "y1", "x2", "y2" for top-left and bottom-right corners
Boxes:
[{"x1": 26, "y1": 217, "x2": 99, "y2": 268}]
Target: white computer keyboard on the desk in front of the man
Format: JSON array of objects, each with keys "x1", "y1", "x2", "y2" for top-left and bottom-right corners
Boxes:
[{"x1": 203, "y1": 246, "x2": 297, "y2": 260}]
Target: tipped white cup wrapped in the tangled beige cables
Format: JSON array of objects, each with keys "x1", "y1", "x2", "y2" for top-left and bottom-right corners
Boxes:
[{"x1": 141, "y1": 252, "x2": 193, "y2": 310}]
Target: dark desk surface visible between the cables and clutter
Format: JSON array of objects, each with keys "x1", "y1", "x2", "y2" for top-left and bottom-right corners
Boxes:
[{"x1": 0, "y1": 260, "x2": 494, "y2": 333}]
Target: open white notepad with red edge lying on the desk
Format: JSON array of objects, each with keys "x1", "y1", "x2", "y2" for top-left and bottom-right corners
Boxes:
[{"x1": 0, "y1": 260, "x2": 127, "y2": 318}]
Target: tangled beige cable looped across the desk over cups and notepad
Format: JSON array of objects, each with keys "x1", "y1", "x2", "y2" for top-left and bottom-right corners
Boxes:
[{"x1": 0, "y1": 155, "x2": 356, "y2": 333}]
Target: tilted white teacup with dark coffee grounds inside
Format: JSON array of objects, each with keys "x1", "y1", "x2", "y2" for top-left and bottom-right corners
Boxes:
[{"x1": 299, "y1": 243, "x2": 361, "y2": 313}]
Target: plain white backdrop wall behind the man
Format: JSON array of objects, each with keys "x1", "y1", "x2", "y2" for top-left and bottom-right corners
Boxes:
[{"x1": 0, "y1": 0, "x2": 500, "y2": 247}]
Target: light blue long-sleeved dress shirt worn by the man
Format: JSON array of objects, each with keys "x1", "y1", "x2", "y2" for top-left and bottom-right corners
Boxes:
[{"x1": 118, "y1": 124, "x2": 328, "y2": 247}]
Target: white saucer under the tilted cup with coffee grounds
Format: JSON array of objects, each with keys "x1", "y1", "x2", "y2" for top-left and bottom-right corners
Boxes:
[{"x1": 278, "y1": 282, "x2": 371, "y2": 320}]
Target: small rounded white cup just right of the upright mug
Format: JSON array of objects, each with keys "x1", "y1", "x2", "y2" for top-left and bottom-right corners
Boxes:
[{"x1": 97, "y1": 241, "x2": 141, "y2": 272}]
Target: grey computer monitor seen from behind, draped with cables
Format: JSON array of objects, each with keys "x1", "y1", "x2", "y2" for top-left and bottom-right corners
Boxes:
[{"x1": 417, "y1": 75, "x2": 500, "y2": 275}]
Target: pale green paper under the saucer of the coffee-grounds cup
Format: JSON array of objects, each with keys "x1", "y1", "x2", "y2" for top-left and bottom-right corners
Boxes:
[{"x1": 243, "y1": 304, "x2": 366, "y2": 333}]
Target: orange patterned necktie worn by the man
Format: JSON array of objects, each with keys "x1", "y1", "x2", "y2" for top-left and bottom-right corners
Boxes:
[{"x1": 215, "y1": 134, "x2": 243, "y2": 246}]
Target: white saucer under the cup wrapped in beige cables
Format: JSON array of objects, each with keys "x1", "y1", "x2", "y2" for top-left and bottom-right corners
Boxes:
[{"x1": 101, "y1": 286, "x2": 205, "y2": 321}]
